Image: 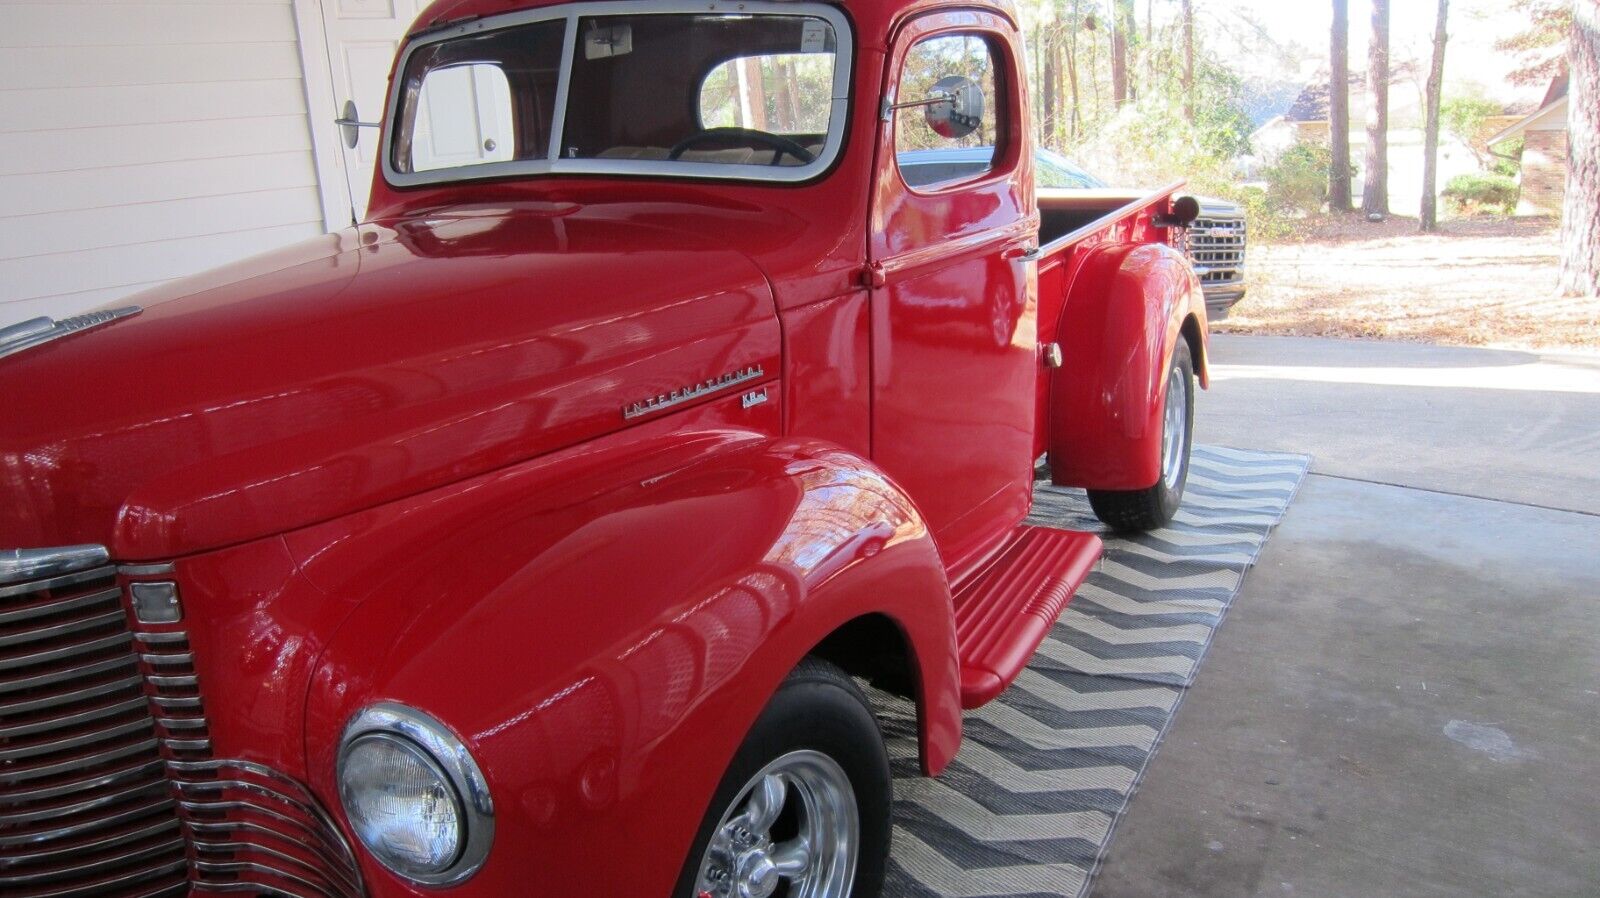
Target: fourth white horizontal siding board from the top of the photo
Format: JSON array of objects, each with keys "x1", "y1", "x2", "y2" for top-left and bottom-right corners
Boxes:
[{"x1": 0, "y1": 115, "x2": 310, "y2": 176}]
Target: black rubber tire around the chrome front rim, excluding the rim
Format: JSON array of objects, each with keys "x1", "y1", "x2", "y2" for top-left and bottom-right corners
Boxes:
[{"x1": 674, "y1": 658, "x2": 893, "y2": 898}]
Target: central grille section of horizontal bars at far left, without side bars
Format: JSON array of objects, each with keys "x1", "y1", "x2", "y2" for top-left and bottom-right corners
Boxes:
[{"x1": 0, "y1": 567, "x2": 189, "y2": 898}]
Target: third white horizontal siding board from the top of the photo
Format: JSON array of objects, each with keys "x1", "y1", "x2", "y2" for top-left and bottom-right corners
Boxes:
[{"x1": 0, "y1": 78, "x2": 306, "y2": 132}]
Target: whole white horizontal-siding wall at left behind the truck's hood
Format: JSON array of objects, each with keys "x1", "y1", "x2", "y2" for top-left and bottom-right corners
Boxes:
[{"x1": 0, "y1": 0, "x2": 323, "y2": 327}]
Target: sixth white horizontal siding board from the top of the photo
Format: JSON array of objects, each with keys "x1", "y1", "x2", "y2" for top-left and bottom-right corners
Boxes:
[{"x1": 0, "y1": 187, "x2": 322, "y2": 259}]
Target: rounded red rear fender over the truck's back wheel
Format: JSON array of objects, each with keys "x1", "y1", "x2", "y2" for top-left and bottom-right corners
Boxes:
[{"x1": 1048, "y1": 243, "x2": 1210, "y2": 490}]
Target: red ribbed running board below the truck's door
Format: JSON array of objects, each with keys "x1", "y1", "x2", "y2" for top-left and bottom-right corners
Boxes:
[{"x1": 954, "y1": 527, "x2": 1101, "y2": 709}]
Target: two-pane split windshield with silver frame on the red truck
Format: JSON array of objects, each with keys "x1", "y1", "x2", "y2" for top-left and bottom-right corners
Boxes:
[{"x1": 384, "y1": 2, "x2": 848, "y2": 186}]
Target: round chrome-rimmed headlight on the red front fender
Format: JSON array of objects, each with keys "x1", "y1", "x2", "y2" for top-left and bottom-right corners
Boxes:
[{"x1": 338, "y1": 704, "x2": 494, "y2": 885}]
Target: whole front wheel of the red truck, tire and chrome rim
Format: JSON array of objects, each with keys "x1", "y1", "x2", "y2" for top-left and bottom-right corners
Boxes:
[{"x1": 674, "y1": 658, "x2": 891, "y2": 898}]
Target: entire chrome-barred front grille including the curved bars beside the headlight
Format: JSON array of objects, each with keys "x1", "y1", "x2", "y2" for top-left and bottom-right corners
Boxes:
[{"x1": 0, "y1": 547, "x2": 363, "y2": 898}]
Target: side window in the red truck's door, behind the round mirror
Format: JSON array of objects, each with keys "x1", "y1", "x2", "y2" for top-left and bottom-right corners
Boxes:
[{"x1": 894, "y1": 34, "x2": 1006, "y2": 187}]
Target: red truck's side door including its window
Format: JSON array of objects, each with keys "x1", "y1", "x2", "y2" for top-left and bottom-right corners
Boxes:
[{"x1": 869, "y1": 11, "x2": 1038, "y2": 567}]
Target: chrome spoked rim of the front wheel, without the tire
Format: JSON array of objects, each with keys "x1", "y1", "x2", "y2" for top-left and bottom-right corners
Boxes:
[{"x1": 694, "y1": 751, "x2": 861, "y2": 898}]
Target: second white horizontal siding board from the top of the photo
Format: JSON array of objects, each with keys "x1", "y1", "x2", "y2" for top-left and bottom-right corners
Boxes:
[{"x1": 0, "y1": 40, "x2": 301, "y2": 90}]
